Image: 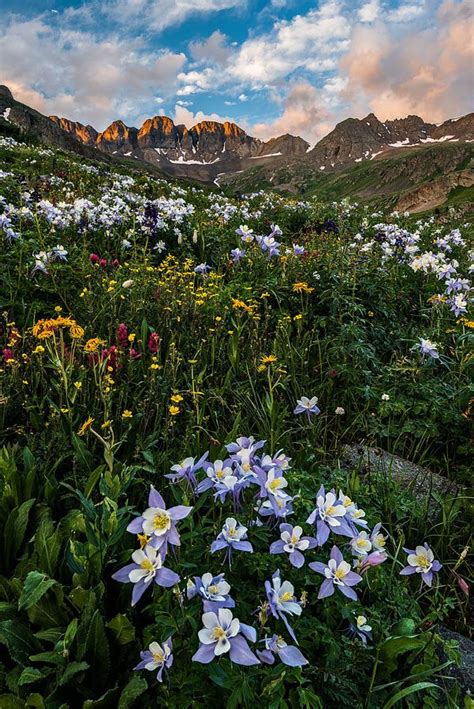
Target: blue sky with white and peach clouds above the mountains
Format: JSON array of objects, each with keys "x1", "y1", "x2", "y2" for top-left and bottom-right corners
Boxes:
[{"x1": 0, "y1": 0, "x2": 474, "y2": 144}]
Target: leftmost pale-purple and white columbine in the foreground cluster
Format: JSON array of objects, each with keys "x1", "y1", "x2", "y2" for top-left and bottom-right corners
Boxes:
[{"x1": 112, "y1": 544, "x2": 179, "y2": 606}]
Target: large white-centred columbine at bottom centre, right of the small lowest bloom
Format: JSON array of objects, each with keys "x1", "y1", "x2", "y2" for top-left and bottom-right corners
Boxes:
[{"x1": 192, "y1": 608, "x2": 259, "y2": 666}]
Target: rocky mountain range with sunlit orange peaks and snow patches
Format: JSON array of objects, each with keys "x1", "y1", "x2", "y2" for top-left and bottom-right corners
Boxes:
[{"x1": 0, "y1": 86, "x2": 474, "y2": 210}]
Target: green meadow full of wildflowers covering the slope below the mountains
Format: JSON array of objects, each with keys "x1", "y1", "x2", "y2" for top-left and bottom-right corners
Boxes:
[{"x1": 0, "y1": 138, "x2": 474, "y2": 709}]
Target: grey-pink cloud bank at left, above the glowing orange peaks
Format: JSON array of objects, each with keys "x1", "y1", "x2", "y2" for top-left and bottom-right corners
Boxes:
[{"x1": 0, "y1": 18, "x2": 186, "y2": 129}]
